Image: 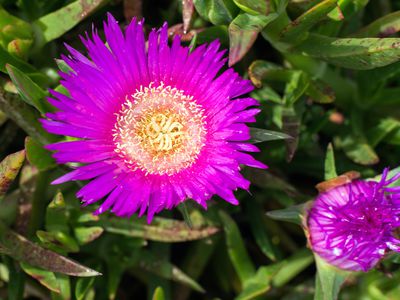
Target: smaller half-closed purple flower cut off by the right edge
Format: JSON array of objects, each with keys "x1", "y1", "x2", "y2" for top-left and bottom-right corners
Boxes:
[{"x1": 307, "y1": 168, "x2": 400, "y2": 271}]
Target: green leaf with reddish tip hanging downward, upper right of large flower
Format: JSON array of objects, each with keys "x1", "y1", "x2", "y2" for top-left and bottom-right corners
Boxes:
[{"x1": 228, "y1": 13, "x2": 278, "y2": 66}]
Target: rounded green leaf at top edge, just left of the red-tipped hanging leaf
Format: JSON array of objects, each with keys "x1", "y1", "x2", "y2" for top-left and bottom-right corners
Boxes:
[{"x1": 193, "y1": 0, "x2": 239, "y2": 25}]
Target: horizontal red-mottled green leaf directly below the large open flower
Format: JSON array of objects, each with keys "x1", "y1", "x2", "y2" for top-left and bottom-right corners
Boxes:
[{"x1": 96, "y1": 217, "x2": 219, "y2": 243}]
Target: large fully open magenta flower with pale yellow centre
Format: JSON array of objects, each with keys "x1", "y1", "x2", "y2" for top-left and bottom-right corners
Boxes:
[{"x1": 42, "y1": 15, "x2": 266, "y2": 222}]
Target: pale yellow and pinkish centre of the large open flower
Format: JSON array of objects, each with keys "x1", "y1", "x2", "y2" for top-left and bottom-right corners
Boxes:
[{"x1": 113, "y1": 83, "x2": 206, "y2": 175}]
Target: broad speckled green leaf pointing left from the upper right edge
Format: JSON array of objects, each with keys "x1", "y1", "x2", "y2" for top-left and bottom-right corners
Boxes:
[{"x1": 291, "y1": 34, "x2": 400, "y2": 70}]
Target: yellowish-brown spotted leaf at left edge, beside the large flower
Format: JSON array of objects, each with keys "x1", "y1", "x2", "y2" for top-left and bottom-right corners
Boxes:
[{"x1": 0, "y1": 150, "x2": 25, "y2": 197}]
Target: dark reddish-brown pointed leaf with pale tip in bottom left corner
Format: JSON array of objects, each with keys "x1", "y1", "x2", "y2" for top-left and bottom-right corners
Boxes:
[{"x1": 0, "y1": 223, "x2": 101, "y2": 277}]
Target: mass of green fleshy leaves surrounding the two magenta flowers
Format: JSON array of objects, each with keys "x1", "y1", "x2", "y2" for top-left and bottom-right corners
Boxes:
[{"x1": 0, "y1": 0, "x2": 400, "y2": 300}]
